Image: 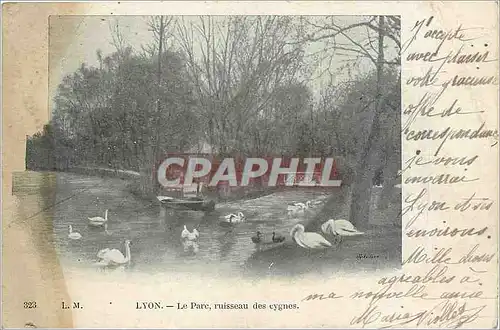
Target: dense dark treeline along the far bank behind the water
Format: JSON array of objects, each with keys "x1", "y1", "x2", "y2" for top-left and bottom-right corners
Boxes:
[{"x1": 26, "y1": 53, "x2": 401, "y2": 178}]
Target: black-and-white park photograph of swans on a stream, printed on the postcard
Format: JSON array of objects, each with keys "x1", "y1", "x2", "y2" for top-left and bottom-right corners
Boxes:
[{"x1": 21, "y1": 15, "x2": 402, "y2": 279}]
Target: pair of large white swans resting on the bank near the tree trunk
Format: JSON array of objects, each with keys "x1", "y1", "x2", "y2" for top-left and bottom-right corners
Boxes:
[{"x1": 290, "y1": 219, "x2": 364, "y2": 249}]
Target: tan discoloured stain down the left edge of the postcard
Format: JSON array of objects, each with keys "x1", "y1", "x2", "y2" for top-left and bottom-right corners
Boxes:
[{"x1": 2, "y1": 3, "x2": 87, "y2": 328}]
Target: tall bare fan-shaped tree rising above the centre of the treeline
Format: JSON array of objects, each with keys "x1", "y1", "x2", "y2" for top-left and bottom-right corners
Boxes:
[{"x1": 176, "y1": 16, "x2": 303, "y2": 153}]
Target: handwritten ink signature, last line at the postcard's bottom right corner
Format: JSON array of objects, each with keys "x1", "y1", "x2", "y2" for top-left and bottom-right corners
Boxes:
[{"x1": 351, "y1": 300, "x2": 486, "y2": 329}]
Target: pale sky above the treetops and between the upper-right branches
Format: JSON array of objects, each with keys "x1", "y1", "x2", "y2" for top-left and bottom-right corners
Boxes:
[{"x1": 49, "y1": 16, "x2": 398, "y2": 105}]
